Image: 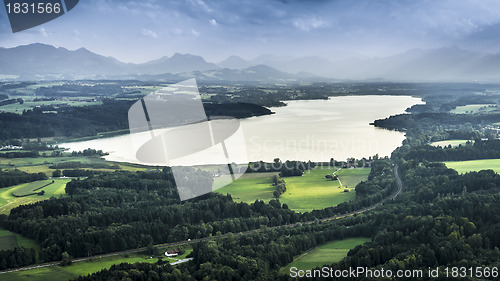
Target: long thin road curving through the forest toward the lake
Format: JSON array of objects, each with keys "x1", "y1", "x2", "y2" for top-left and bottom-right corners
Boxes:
[{"x1": 0, "y1": 164, "x2": 403, "y2": 274}]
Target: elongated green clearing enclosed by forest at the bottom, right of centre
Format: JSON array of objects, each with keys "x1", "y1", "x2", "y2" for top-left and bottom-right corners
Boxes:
[{"x1": 281, "y1": 237, "x2": 370, "y2": 273}]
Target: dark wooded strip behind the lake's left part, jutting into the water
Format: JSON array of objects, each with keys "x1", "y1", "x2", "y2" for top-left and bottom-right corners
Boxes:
[{"x1": 0, "y1": 99, "x2": 271, "y2": 140}]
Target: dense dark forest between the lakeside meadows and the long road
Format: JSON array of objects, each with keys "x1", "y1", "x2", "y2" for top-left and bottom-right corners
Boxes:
[{"x1": 0, "y1": 159, "x2": 395, "y2": 266}]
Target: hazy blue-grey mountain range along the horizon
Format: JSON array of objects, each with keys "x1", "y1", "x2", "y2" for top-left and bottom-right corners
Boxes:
[{"x1": 0, "y1": 43, "x2": 500, "y2": 82}]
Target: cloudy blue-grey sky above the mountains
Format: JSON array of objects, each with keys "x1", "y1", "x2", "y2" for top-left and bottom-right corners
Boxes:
[{"x1": 0, "y1": 0, "x2": 500, "y2": 62}]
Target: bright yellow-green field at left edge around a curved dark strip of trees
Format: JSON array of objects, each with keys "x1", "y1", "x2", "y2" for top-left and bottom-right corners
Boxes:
[{"x1": 0, "y1": 178, "x2": 71, "y2": 215}]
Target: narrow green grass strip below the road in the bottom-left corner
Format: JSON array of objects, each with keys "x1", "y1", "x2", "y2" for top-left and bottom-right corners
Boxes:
[{"x1": 0, "y1": 249, "x2": 192, "y2": 281}]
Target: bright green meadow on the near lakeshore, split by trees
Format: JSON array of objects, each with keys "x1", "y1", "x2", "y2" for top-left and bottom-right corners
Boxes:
[{"x1": 216, "y1": 168, "x2": 370, "y2": 212}]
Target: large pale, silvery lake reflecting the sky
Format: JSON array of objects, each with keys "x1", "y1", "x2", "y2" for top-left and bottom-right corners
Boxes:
[{"x1": 60, "y1": 96, "x2": 423, "y2": 165}]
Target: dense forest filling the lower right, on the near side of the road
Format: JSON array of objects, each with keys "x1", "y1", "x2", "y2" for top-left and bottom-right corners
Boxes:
[{"x1": 60, "y1": 137, "x2": 500, "y2": 280}]
